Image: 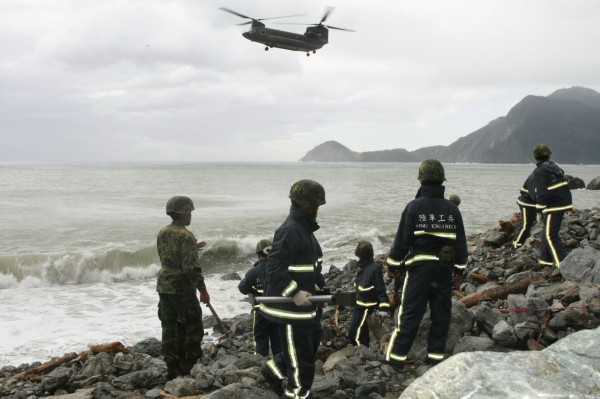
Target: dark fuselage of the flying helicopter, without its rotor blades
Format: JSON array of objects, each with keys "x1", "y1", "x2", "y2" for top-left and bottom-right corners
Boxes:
[{"x1": 242, "y1": 24, "x2": 328, "y2": 52}]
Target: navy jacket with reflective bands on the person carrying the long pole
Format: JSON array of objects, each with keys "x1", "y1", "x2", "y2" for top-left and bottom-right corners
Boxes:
[{"x1": 260, "y1": 206, "x2": 321, "y2": 324}]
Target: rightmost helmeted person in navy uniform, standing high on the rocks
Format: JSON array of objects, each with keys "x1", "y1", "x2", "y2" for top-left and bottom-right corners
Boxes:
[{"x1": 533, "y1": 144, "x2": 573, "y2": 268}]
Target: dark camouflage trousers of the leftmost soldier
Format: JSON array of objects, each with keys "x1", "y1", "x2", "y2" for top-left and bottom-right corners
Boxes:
[{"x1": 158, "y1": 293, "x2": 204, "y2": 377}]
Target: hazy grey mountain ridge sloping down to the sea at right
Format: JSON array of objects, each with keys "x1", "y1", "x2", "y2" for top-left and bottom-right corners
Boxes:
[{"x1": 300, "y1": 86, "x2": 600, "y2": 164}]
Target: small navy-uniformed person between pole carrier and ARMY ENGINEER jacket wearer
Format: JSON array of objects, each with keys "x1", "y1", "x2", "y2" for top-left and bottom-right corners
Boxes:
[{"x1": 348, "y1": 241, "x2": 390, "y2": 348}]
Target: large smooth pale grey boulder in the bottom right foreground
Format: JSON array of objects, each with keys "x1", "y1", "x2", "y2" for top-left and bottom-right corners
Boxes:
[{"x1": 399, "y1": 328, "x2": 600, "y2": 399}]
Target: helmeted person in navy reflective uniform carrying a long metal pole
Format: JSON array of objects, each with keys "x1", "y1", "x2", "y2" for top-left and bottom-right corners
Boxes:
[{"x1": 260, "y1": 180, "x2": 325, "y2": 399}]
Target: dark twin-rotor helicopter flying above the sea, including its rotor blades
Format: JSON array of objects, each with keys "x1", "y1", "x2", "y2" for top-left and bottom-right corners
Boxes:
[{"x1": 220, "y1": 7, "x2": 354, "y2": 57}]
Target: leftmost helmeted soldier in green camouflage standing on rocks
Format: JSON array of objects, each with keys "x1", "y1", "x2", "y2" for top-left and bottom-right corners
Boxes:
[{"x1": 156, "y1": 196, "x2": 210, "y2": 379}]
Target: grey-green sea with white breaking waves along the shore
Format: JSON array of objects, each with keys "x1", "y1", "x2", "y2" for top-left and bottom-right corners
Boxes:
[{"x1": 0, "y1": 162, "x2": 600, "y2": 367}]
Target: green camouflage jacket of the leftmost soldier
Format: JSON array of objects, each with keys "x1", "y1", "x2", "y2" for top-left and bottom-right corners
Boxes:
[{"x1": 156, "y1": 222, "x2": 206, "y2": 295}]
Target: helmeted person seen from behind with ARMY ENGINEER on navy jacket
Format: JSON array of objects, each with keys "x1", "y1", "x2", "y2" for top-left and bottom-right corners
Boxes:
[{"x1": 386, "y1": 159, "x2": 468, "y2": 369}]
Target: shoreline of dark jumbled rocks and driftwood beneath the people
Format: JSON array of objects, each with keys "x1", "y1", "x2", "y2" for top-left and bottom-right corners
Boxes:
[{"x1": 0, "y1": 208, "x2": 600, "y2": 399}]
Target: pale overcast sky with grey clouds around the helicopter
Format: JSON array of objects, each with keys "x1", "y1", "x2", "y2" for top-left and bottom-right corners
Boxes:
[{"x1": 0, "y1": 0, "x2": 600, "y2": 162}]
